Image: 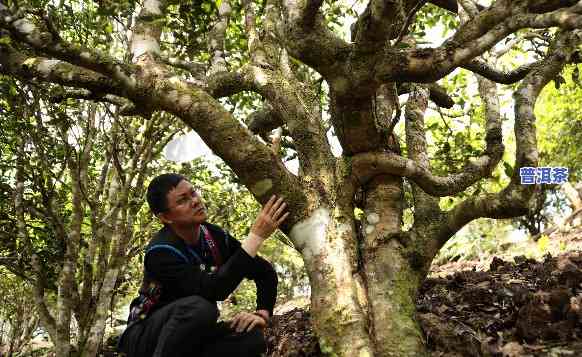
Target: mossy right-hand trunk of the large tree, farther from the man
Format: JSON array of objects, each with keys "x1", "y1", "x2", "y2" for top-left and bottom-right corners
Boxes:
[{"x1": 363, "y1": 175, "x2": 425, "y2": 356}]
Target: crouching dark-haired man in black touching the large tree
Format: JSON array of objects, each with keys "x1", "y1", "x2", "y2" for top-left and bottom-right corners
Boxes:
[{"x1": 118, "y1": 174, "x2": 288, "y2": 357}]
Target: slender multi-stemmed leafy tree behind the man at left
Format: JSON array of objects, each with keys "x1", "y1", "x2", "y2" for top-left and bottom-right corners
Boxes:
[{"x1": 1, "y1": 75, "x2": 180, "y2": 356}]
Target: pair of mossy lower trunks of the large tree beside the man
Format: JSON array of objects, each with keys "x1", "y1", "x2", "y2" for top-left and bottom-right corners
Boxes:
[{"x1": 291, "y1": 196, "x2": 432, "y2": 356}]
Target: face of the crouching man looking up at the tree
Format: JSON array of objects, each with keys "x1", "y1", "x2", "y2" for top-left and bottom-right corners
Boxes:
[{"x1": 159, "y1": 180, "x2": 208, "y2": 226}]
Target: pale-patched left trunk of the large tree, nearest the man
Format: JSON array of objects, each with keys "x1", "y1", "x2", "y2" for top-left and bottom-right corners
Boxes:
[{"x1": 291, "y1": 207, "x2": 373, "y2": 356}]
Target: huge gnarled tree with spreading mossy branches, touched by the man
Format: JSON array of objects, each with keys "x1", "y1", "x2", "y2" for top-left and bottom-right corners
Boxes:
[{"x1": 0, "y1": 0, "x2": 582, "y2": 356}]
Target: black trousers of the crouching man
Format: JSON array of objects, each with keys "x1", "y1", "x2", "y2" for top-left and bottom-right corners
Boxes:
[{"x1": 119, "y1": 296, "x2": 267, "y2": 357}]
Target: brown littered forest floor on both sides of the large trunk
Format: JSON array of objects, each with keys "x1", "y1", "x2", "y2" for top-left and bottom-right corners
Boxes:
[{"x1": 267, "y1": 229, "x2": 582, "y2": 357}]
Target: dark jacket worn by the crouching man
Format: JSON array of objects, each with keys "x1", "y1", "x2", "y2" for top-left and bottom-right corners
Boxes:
[{"x1": 131, "y1": 223, "x2": 277, "y2": 315}]
